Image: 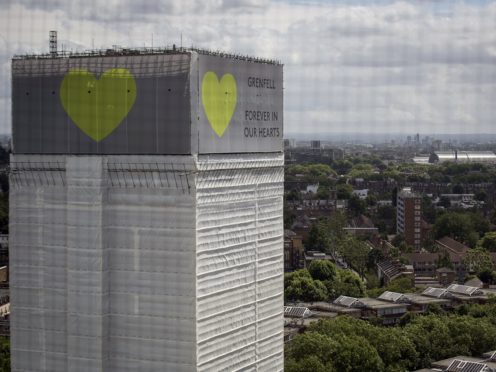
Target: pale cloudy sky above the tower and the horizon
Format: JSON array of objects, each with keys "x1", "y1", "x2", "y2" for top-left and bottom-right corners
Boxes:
[{"x1": 0, "y1": 0, "x2": 496, "y2": 135}]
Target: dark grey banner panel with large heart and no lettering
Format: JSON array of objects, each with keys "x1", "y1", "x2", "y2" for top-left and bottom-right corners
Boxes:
[{"x1": 12, "y1": 53, "x2": 191, "y2": 154}]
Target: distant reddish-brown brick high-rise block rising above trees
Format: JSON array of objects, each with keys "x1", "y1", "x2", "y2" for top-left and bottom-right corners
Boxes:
[{"x1": 396, "y1": 187, "x2": 422, "y2": 250}]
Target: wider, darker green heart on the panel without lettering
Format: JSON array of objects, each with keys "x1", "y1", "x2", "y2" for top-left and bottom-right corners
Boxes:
[{"x1": 60, "y1": 68, "x2": 136, "y2": 142}]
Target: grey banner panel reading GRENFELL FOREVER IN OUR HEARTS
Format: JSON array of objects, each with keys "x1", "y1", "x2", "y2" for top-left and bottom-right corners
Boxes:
[{"x1": 197, "y1": 55, "x2": 283, "y2": 154}]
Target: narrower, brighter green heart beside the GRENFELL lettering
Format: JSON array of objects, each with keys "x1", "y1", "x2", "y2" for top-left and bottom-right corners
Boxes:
[{"x1": 202, "y1": 71, "x2": 238, "y2": 137}]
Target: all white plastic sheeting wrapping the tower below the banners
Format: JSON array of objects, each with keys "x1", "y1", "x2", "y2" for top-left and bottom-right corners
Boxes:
[{"x1": 10, "y1": 154, "x2": 283, "y2": 372}]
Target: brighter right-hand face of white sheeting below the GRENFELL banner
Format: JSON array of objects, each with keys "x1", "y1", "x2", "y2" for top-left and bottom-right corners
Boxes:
[{"x1": 196, "y1": 154, "x2": 284, "y2": 371}]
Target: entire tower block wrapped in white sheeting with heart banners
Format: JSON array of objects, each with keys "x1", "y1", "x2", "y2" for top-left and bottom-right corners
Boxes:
[{"x1": 10, "y1": 49, "x2": 284, "y2": 372}]
